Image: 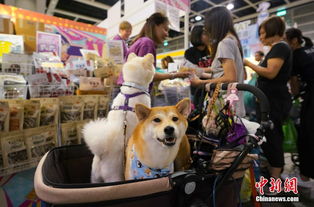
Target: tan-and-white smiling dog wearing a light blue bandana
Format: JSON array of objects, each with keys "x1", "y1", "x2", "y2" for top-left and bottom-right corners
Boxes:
[{"x1": 124, "y1": 98, "x2": 191, "y2": 180}]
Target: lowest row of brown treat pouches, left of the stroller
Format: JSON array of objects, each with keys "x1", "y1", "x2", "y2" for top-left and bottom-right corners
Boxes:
[{"x1": 0, "y1": 125, "x2": 58, "y2": 176}]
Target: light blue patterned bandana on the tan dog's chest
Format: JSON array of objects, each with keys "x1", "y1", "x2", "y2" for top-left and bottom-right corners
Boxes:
[{"x1": 130, "y1": 145, "x2": 173, "y2": 180}]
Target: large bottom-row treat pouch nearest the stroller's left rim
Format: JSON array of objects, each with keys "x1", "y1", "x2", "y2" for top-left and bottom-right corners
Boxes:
[{"x1": 25, "y1": 126, "x2": 57, "y2": 161}]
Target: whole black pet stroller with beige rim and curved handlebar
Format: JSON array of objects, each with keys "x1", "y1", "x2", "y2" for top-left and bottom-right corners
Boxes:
[{"x1": 34, "y1": 84, "x2": 269, "y2": 207}]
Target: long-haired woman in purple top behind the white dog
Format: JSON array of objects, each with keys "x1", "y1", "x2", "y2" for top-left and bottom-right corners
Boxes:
[{"x1": 118, "y1": 12, "x2": 190, "y2": 84}]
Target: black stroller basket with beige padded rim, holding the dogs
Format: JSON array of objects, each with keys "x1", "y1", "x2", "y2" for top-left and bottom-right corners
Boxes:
[{"x1": 34, "y1": 145, "x2": 171, "y2": 206}]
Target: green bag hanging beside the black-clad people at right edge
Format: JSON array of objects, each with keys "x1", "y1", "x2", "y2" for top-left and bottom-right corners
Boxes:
[{"x1": 282, "y1": 118, "x2": 298, "y2": 152}]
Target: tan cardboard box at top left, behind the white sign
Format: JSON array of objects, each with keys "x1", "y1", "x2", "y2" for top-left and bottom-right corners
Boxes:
[{"x1": 15, "y1": 18, "x2": 45, "y2": 52}]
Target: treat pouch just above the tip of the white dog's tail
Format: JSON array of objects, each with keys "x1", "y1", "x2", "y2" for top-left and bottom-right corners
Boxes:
[{"x1": 80, "y1": 95, "x2": 98, "y2": 120}]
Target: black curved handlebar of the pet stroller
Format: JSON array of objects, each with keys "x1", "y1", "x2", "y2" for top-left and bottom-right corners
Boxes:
[{"x1": 206, "y1": 83, "x2": 270, "y2": 122}]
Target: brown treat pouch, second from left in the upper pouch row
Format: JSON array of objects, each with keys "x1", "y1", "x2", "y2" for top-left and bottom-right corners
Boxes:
[{"x1": 7, "y1": 100, "x2": 24, "y2": 131}]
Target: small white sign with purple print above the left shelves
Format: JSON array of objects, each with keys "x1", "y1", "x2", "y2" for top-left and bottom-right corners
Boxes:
[{"x1": 36, "y1": 31, "x2": 61, "y2": 57}]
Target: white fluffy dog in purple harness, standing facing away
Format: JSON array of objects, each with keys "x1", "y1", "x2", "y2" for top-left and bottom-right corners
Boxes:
[{"x1": 83, "y1": 53, "x2": 155, "y2": 183}]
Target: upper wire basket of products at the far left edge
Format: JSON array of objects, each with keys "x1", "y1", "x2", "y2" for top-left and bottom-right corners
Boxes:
[{"x1": 0, "y1": 62, "x2": 35, "y2": 77}]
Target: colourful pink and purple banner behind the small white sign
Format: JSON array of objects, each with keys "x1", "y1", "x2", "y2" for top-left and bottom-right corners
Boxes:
[{"x1": 45, "y1": 25, "x2": 106, "y2": 62}]
